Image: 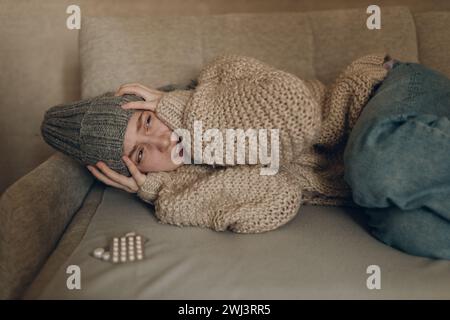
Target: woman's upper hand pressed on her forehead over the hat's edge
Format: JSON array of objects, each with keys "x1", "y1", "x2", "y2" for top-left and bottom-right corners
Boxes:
[{"x1": 115, "y1": 83, "x2": 163, "y2": 112}]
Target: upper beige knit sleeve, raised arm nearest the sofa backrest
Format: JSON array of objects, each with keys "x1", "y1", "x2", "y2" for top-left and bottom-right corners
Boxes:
[{"x1": 153, "y1": 54, "x2": 321, "y2": 170}]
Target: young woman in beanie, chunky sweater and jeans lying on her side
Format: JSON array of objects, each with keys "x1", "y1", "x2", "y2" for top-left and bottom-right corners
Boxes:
[{"x1": 42, "y1": 54, "x2": 450, "y2": 259}]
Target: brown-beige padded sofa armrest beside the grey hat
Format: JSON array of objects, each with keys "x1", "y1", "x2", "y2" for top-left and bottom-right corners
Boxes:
[{"x1": 0, "y1": 152, "x2": 94, "y2": 299}]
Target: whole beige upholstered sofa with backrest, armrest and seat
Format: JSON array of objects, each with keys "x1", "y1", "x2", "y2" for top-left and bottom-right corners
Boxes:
[{"x1": 0, "y1": 6, "x2": 450, "y2": 299}]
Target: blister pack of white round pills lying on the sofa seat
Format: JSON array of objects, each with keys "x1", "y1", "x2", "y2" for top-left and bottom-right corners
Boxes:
[{"x1": 92, "y1": 232, "x2": 148, "y2": 263}]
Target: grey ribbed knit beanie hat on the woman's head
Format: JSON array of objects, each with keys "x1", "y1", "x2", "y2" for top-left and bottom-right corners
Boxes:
[{"x1": 41, "y1": 92, "x2": 143, "y2": 176}]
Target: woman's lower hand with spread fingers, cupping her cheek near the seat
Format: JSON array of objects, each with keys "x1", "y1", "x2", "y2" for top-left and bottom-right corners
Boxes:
[{"x1": 87, "y1": 156, "x2": 147, "y2": 193}]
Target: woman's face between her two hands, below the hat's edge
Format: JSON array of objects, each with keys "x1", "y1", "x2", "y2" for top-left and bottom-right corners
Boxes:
[{"x1": 123, "y1": 110, "x2": 183, "y2": 173}]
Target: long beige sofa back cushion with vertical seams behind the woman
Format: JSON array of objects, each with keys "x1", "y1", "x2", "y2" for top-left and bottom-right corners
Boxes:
[{"x1": 80, "y1": 7, "x2": 417, "y2": 98}]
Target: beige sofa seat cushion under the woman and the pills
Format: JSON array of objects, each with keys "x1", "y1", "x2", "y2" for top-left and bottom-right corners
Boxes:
[{"x1": 26, "y1": 187, "x2": 450, "y2": 299}]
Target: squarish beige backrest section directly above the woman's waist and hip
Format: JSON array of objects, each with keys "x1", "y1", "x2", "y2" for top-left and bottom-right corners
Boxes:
[{"x1": 309, "y1": 6, "x2": 418, "y2": 83}]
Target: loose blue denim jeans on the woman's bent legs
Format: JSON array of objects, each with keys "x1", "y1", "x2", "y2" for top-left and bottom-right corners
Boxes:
[{"x1": 344, "y1": 61, "x2": 450, "y2": 259}]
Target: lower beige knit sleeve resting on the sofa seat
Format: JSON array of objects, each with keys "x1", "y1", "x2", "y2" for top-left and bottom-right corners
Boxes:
[{"x1": 151, "y1": 166, "x2": 301, "y2": 233}]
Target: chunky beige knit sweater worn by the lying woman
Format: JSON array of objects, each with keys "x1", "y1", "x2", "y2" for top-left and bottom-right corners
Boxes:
[{"x1": 138, "y1": 54, "x2": 388, "y2": 233}]
